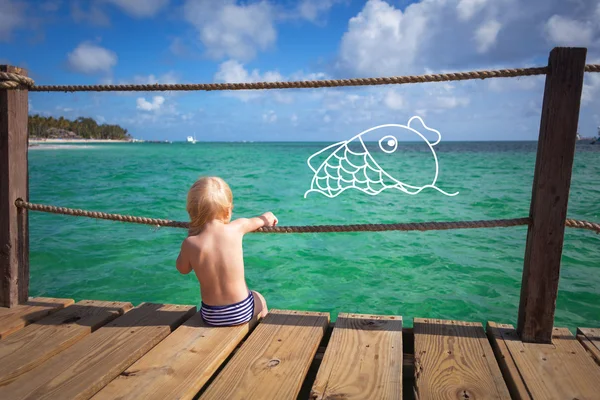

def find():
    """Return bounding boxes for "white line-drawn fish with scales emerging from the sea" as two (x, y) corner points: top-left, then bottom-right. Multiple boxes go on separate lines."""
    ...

(304, 116), (458, 198)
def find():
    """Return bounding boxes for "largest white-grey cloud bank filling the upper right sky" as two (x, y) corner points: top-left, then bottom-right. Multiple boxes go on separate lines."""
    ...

(335, 0), (600, 77)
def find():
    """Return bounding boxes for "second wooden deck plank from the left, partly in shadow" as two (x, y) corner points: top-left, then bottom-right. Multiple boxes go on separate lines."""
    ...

(0, 300), (132, 386)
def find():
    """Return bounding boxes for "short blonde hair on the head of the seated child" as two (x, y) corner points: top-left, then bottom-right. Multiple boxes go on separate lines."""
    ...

(186, 176), (233, 235)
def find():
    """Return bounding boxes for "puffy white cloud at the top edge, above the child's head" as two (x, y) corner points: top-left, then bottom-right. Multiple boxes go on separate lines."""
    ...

(184, 0), (277, 60)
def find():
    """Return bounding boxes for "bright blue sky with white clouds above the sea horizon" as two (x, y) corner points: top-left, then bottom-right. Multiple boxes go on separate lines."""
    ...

(0, 0), (600, 141)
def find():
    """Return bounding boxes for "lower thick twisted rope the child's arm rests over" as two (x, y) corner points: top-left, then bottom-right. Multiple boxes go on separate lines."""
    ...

(15, 199), (600, 233)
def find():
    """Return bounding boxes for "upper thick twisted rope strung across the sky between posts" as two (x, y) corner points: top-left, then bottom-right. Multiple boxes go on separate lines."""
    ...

(0, 64), (600, 92)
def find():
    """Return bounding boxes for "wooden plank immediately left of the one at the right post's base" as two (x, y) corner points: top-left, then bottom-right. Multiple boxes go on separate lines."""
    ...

(414, 318), (510, 400)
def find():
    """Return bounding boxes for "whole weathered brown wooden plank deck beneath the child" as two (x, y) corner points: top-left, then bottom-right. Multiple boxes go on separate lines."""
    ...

(0, 298), (600, 400)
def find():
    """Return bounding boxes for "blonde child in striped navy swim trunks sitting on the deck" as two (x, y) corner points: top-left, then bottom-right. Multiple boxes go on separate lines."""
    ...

(177, 177), (277, 326)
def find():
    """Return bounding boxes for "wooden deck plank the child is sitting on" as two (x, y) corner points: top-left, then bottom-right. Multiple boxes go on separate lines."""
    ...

(93, 313), (256, 400)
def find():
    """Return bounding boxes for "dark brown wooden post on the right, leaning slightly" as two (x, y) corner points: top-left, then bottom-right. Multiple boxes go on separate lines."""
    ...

(517, 47), (587, 343)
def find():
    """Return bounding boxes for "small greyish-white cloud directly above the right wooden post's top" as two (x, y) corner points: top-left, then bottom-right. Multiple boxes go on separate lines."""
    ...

(545, 15), (594, 46)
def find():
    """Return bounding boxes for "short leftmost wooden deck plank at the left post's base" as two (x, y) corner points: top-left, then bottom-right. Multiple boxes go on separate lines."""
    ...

(0, 297), (74, 339)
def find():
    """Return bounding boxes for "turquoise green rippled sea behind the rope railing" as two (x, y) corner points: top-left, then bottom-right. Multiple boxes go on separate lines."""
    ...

(29, 142), (600, 330)
